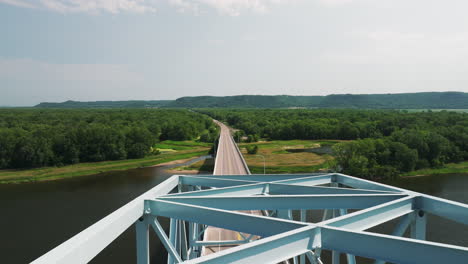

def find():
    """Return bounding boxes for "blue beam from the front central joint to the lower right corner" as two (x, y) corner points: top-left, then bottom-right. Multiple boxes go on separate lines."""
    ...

(321, 227), (468, 264)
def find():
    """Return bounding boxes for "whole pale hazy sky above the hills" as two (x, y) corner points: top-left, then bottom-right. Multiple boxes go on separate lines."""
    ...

(0, 0), (468, 106)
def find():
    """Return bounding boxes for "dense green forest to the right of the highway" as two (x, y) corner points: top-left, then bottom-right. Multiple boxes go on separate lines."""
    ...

(200, 109), (468, 178)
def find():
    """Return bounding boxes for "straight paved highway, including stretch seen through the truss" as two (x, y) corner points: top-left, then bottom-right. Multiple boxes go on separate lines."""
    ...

(202, 120), (261, 256)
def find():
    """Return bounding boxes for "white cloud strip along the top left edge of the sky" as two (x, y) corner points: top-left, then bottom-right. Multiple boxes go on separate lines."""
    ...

(0, 0), (156, 14)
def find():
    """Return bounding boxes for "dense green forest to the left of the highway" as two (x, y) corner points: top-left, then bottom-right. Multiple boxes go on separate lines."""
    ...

(0, 109), (216, 169)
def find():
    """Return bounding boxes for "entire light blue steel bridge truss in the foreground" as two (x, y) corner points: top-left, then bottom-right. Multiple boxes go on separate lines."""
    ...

(33, 173), (468, 264)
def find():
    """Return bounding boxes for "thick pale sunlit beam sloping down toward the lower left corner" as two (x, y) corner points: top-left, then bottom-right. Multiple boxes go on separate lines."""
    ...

(29, 176), (179, 264)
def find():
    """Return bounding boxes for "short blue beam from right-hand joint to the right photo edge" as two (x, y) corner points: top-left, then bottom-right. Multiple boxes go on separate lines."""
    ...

(416, 195), (468, 225)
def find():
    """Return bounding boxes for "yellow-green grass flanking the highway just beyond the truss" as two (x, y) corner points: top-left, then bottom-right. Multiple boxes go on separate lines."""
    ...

(176, 140), (339, 174)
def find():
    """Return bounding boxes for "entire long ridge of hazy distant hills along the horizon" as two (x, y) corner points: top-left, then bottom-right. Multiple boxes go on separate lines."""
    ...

(36, 92), (468, 109)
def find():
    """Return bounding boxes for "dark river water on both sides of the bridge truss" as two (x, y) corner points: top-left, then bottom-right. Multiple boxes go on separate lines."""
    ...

(0, 165), (468, 264)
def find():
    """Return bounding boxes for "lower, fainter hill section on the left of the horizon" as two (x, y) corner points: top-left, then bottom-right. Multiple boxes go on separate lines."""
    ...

(35, 100), (171, 108)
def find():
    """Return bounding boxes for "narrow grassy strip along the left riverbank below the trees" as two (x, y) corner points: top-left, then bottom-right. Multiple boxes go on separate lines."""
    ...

(0, 141), (211, 184)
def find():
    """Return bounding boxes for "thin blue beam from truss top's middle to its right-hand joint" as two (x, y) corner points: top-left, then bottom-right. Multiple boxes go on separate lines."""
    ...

(268, 183), (394, 195)
